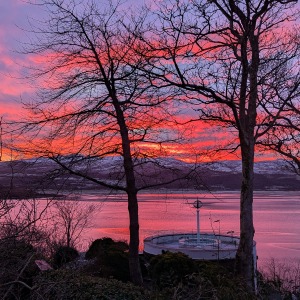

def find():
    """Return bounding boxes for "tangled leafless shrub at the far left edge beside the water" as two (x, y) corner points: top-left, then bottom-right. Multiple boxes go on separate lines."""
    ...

(0, 199), (49, 299)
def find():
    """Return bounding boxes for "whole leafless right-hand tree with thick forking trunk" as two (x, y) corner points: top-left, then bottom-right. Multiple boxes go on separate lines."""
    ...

(139, 0), (299, 289)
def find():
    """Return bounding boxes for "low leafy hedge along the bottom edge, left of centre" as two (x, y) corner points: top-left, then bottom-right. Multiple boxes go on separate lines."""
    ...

(31, 269), (151, 300)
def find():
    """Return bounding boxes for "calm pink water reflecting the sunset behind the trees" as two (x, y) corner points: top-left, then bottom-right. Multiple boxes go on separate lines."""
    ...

(73, 192), (300, 264)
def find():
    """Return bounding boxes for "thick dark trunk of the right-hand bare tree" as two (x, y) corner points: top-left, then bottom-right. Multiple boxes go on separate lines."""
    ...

(237, 31), (259, 291)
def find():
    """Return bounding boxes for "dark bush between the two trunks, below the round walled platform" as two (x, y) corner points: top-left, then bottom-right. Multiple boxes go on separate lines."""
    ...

(150, 252), (256, 300)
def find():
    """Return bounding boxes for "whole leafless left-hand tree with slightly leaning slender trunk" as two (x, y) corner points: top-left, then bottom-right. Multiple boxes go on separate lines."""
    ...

(19, 0), (191, 284)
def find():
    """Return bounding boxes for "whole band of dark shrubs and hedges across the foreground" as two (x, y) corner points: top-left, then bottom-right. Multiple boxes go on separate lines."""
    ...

(0, 238), (300, 300)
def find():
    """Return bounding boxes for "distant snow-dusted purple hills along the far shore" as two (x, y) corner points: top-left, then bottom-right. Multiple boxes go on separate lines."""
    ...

(0, 156), (300, 198)
